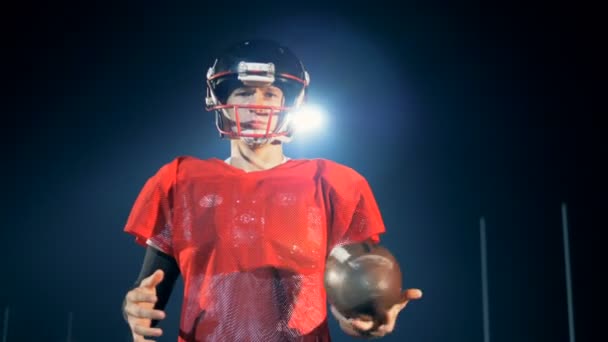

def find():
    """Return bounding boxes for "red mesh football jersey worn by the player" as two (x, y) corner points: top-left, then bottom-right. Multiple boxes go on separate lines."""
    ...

(125, 157), (384, 342)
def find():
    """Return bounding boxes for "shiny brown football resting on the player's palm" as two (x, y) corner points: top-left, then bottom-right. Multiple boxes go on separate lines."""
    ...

(324, 242), (402, 319)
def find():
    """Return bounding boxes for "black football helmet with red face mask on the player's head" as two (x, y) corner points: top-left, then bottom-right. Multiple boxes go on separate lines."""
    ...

(206, 41), (310, 145)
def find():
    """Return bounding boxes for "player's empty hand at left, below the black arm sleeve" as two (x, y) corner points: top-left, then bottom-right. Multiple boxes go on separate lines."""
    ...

(124, 270), (165, 342)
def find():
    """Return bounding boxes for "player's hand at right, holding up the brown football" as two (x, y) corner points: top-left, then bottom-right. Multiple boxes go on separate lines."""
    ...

(331, 289), (422, 338)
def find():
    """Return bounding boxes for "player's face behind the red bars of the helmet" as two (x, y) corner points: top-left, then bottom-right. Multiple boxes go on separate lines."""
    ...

(226, 86), (283, 134)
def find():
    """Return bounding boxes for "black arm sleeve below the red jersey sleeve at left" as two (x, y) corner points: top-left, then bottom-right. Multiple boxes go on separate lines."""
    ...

(123, 246), (180, 326)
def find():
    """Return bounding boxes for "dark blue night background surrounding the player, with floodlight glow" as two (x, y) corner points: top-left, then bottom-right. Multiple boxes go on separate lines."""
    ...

(0, 1), (601, 342)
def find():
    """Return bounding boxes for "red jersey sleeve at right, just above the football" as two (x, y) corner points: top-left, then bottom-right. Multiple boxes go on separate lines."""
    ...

(329, 177), (385, 249)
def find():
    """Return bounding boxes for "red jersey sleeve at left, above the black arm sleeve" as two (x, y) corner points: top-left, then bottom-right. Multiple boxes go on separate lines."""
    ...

(124, 159), (178, 255)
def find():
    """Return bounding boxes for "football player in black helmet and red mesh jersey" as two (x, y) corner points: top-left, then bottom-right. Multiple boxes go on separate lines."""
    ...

(123, 41), (421, 342)
